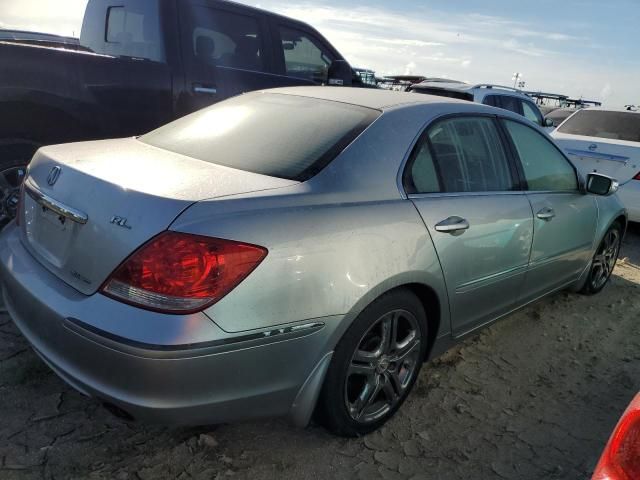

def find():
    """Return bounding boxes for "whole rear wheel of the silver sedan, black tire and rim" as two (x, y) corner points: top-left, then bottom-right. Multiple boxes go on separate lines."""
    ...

(316, 289), (428, 437)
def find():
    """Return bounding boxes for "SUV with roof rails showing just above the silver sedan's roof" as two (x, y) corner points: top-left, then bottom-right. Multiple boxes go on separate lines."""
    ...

(407, 79), (550, 127)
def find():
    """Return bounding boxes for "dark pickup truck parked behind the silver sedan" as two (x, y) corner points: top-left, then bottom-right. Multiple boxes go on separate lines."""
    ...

(0, 0), (354, 225)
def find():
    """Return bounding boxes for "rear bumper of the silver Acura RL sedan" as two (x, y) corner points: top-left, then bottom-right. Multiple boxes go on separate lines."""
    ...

(0, 227), (341, 425)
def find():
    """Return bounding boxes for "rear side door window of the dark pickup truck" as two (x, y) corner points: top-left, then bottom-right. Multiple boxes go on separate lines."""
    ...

(187, 7), (264, 71)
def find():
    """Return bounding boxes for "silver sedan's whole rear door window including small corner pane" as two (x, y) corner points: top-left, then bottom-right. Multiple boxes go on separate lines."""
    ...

(405, 117), (517, 193)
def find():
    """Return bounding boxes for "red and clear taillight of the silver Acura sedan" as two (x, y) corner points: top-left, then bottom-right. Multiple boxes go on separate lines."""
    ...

(102, 231), (267, 313)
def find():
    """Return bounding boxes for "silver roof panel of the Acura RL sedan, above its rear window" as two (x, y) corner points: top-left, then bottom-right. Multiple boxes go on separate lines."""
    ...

(263, 87), (468, 110)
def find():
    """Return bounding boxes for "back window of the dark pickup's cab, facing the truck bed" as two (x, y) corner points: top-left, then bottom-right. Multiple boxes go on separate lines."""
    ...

(104, 1), (164, 62)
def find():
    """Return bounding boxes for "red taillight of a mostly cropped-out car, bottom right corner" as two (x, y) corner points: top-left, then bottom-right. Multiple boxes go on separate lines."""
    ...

(592, 395), (640, 480)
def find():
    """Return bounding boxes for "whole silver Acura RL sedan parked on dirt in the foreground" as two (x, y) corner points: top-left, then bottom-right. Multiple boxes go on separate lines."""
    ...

(0, 87), (627, 436)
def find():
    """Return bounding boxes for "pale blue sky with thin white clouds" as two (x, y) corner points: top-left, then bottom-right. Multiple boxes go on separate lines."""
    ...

(0, 0), (640, 106)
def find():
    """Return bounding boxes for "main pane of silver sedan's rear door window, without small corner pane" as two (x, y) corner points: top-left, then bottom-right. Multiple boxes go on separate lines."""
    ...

(428, 117), (515, 192)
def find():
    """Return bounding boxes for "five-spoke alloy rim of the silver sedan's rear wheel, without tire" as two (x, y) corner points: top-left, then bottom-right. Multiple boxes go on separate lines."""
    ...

(345, 310), (422, 423)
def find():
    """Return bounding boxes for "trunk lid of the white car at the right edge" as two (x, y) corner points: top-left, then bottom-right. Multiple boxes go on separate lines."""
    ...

(552, 132), (640, 184)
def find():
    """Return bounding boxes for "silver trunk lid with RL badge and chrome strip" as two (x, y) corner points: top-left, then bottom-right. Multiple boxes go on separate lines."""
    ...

(20, 139), (297, 295)
